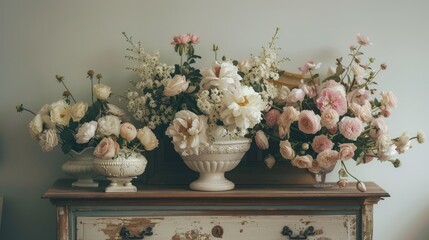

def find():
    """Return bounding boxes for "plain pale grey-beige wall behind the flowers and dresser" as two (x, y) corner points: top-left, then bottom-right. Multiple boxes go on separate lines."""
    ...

(0, 0), (429, 240)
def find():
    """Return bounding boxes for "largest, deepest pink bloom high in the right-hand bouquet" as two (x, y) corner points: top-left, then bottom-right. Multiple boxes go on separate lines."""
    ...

(316, 88), (347, 116)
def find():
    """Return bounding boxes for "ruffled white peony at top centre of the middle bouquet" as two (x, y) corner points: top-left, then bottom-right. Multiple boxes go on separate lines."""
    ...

(200, 62), (243, 91)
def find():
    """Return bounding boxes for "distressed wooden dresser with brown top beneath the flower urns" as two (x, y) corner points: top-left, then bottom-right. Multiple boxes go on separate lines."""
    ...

(43, 180), (389, 240)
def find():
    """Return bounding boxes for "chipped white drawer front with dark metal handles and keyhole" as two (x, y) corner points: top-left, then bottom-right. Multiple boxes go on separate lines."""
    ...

(76, 215), (356, 240)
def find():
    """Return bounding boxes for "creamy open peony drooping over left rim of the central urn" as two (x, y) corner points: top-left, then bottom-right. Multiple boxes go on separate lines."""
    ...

(165, 110), (208, 156)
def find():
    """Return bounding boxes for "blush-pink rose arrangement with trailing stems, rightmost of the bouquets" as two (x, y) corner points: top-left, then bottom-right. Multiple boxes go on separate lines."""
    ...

(255, 35), (424, 191)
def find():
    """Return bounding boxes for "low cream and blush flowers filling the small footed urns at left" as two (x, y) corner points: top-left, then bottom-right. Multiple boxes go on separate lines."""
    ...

(16, 70), (158, 159)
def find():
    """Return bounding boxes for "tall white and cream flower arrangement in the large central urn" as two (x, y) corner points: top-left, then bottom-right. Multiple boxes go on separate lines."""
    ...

(123, 33), (279, 156)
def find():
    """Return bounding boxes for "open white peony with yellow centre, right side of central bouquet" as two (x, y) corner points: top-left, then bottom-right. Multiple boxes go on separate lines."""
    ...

(220, 86), (266, 130)
